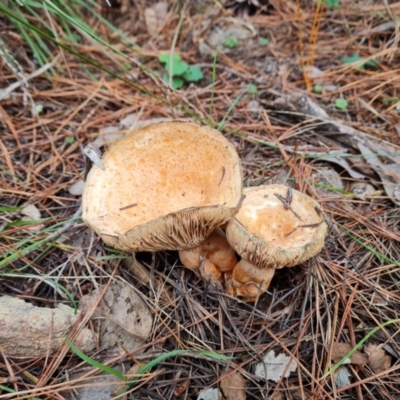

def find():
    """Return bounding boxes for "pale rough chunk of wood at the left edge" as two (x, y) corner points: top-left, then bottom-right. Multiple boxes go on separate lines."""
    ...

(0, 296), (96, 358)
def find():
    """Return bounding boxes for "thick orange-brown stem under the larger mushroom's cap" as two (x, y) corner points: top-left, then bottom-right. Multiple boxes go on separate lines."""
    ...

(179, 228), (237, 282)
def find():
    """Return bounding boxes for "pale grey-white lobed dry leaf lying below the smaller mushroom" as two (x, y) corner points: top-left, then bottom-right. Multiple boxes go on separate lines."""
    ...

(255, 350), (297, 382)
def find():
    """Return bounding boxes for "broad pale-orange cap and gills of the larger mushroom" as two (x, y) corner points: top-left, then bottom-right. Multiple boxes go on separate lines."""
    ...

(82, 122), (242, 260)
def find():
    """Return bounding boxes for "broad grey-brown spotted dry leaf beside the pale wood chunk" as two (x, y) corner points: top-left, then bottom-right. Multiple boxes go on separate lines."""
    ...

(80, 282), (153, 355)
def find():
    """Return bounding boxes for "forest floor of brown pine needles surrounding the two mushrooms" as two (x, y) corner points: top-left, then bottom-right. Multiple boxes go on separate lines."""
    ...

(0, 0), (400, 400)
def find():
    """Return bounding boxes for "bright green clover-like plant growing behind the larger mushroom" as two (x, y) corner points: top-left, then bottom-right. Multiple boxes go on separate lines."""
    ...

(158, 53), (203, 89)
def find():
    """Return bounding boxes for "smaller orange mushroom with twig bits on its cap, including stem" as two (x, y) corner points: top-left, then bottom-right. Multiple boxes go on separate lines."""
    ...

(226, 184), (328, 301)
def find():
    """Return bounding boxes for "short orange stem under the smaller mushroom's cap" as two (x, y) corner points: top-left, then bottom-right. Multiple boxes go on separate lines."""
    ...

(227, 258), (275, 301)
